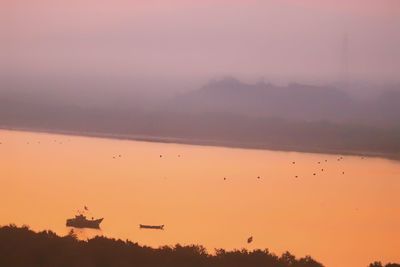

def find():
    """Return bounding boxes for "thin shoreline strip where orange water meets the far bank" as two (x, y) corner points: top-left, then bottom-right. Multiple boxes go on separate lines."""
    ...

(0, 125), (400, 161)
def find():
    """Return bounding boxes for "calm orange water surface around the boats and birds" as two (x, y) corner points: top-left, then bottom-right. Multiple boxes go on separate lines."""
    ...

(0, 131), (400, 267)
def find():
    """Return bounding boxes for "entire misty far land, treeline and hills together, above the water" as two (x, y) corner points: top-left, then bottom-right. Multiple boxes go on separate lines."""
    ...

(0, 79), (400, 158)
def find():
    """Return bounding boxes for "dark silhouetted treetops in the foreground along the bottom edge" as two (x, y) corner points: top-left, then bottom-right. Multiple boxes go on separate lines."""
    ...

(0, 225), (400, 267)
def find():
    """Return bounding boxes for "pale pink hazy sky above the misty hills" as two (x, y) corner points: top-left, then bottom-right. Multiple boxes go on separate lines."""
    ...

(0, 0), (400, 84)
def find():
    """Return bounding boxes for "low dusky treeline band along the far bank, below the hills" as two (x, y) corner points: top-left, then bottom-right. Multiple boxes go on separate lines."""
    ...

(0, 105), (400, 158)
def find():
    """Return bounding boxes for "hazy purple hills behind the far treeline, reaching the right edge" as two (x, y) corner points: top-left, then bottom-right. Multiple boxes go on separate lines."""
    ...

(166, 78), (400, 126)
